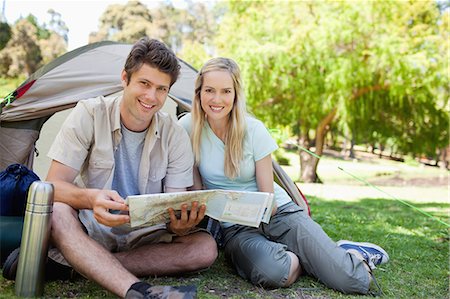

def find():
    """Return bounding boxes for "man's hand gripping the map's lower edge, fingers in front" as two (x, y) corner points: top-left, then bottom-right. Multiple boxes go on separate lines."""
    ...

(169, 201), (206, 236)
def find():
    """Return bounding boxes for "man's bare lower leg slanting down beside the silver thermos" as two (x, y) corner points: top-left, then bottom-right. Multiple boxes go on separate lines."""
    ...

(52, 202), (139, 298)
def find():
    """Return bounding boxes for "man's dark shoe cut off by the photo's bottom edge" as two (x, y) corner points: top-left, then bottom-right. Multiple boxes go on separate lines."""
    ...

(125, 281), (197, 299)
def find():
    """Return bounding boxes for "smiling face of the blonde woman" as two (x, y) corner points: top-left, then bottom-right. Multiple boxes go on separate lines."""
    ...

(200, 71), (236, 122)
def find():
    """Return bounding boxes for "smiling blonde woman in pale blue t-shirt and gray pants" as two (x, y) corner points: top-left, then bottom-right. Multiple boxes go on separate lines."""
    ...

(180, 58), (389, 294)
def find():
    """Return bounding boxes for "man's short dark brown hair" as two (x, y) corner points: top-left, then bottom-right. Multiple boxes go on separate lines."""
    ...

(124, 37), (180, 86)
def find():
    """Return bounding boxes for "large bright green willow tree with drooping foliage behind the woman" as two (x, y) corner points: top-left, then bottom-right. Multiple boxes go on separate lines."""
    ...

(217, 1), (448, 182)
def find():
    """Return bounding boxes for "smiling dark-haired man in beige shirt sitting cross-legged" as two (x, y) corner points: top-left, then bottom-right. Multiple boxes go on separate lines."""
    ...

(3, 37), (217, 298)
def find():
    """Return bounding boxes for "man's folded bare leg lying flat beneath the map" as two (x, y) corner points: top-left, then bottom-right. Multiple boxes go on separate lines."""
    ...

(114, 232), (217, 277)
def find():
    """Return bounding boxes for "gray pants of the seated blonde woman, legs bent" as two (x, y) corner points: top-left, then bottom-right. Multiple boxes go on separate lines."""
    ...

(224, 202), (369, 294)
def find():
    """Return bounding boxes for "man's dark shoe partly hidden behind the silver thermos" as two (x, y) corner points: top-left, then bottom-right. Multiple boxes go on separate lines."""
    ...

(2, 247), (81, 281)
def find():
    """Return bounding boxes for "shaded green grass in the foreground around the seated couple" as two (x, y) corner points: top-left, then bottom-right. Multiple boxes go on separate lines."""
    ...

(0, 197), (450, 298)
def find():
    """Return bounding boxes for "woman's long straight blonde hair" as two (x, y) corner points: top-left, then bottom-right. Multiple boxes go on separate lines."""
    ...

(191, 57), (247, 178)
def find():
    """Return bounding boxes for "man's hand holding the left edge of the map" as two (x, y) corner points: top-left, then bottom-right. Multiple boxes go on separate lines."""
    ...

(91, 190), (130, 226)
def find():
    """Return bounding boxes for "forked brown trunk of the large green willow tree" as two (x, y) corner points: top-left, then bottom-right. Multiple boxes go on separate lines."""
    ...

(299, 108), (337, 183)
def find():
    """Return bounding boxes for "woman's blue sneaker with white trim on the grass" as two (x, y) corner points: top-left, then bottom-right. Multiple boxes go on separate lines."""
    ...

(336, 240), (389, 269)
